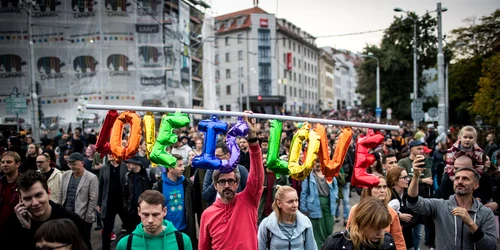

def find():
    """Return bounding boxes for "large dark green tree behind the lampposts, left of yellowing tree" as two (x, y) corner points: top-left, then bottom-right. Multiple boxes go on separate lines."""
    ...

(357, 13), (437, 119)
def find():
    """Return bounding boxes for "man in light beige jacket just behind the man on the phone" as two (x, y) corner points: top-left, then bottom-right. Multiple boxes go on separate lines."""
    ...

(36, 154), (62, 203)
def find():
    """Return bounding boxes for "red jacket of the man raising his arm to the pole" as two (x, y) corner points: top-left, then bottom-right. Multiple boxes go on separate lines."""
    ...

(198, 144), (264, 250)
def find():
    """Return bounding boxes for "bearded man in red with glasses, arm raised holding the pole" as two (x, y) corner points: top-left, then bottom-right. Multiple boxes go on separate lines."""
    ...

(198, 111), (264, 250)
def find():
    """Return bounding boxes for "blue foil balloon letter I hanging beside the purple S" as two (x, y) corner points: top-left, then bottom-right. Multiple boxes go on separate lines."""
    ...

(192, 115), (232, 169)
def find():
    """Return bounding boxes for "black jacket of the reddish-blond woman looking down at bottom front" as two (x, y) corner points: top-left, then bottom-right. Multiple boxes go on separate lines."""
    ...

(321, 230), (396, 250)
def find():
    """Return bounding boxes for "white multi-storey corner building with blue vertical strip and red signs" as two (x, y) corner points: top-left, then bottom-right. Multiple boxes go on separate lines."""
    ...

(215, 7), (319, 114)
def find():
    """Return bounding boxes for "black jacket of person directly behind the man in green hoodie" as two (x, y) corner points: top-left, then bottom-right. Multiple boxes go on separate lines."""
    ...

(123, 167), (154, 215)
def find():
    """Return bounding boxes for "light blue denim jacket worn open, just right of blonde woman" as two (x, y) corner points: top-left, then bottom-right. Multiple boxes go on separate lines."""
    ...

(299, 172), (339, 219)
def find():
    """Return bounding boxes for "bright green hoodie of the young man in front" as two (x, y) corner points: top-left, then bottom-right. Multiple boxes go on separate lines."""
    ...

(116, 220), (193, 250)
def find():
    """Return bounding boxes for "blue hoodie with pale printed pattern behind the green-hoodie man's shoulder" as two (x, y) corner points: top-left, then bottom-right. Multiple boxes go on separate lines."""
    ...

(162, 172), (187, 231)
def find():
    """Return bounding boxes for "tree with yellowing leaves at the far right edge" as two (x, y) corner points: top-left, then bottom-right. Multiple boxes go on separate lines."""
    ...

(447, 9), (500, 124)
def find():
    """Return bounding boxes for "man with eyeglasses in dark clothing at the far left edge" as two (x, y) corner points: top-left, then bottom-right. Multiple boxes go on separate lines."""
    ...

(0, 151), (21, 231)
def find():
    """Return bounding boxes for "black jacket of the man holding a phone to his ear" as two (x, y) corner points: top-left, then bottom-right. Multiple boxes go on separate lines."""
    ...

(0, 201), (92, 250)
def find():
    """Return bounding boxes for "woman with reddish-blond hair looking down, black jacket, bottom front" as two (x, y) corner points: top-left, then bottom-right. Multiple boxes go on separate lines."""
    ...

(321, 196), (396, 250)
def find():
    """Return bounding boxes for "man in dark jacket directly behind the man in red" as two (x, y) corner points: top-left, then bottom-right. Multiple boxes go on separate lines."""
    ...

(201, 143), (248, 206)
